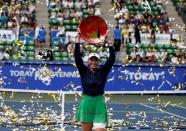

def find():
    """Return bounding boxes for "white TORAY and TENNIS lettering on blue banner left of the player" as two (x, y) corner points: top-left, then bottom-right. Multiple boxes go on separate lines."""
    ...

(10, 70), (79, 80)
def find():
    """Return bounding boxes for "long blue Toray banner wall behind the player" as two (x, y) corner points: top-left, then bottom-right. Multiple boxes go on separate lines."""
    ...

(1, 62), (186, 92)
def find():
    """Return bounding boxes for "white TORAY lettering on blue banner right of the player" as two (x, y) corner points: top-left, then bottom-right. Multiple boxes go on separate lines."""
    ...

(121, 70), (164, 81)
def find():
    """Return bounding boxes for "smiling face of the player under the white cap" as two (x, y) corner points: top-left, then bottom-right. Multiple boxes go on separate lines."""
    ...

(88, 56), (100, 71)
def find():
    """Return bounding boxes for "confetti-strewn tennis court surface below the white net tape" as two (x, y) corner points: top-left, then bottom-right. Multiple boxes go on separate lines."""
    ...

(0, 93), (186, 131)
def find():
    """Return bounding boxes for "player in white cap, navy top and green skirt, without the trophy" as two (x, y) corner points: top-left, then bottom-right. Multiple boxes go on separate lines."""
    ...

(74, 33), (115, 131)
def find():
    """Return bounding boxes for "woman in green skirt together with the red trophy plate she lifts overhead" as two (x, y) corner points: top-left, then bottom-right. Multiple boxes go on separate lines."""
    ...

(74, 16), (115, 131)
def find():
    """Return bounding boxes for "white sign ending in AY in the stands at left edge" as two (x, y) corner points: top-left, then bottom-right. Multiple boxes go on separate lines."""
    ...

(0, 30), (16, 41)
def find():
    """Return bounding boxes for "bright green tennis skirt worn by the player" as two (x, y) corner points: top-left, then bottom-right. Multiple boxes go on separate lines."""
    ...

(76, 95), (108, 123)
